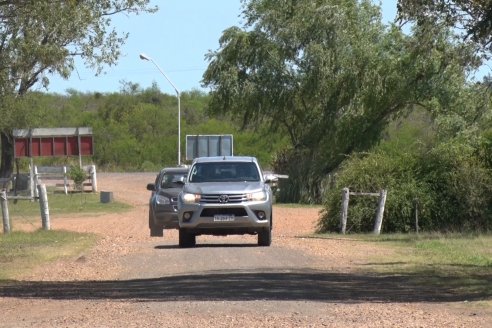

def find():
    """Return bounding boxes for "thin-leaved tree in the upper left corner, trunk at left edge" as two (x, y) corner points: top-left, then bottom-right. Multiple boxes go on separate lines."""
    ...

(0, 0), (157, 177)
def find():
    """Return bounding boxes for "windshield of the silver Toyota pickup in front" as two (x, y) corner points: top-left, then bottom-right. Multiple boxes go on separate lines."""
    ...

(190, 162), (260, 182)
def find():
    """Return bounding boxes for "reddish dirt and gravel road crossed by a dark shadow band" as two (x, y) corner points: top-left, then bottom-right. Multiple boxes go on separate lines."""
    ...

(0, 174), (492, 327)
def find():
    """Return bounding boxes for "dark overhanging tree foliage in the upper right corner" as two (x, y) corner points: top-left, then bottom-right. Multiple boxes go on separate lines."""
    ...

(398, 0), (492, 52)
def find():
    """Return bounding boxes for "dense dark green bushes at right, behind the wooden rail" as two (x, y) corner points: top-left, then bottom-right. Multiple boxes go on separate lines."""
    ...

(318, 142), (492, 232)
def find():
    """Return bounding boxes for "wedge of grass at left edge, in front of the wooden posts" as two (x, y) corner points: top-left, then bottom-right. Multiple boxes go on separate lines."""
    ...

(0, 230), (97, 281)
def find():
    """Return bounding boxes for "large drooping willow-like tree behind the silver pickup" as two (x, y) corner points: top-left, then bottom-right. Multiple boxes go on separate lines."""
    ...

(203, 0), (475, 202)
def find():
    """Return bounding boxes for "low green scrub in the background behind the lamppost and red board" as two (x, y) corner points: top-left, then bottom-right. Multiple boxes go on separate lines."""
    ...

(11, 88), (286, 172)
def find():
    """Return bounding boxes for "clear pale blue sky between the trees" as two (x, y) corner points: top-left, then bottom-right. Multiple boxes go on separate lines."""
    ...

(42, 0), (397, 94)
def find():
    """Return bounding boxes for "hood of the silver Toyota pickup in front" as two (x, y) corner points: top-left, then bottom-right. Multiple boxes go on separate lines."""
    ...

(183, 181), (265, 194)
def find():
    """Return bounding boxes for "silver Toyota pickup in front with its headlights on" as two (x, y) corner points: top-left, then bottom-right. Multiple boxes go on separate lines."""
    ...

(178, 156), (272, 247)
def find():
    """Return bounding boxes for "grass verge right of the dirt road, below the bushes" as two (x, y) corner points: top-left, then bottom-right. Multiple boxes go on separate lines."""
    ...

(319, 233), (492, 307)
